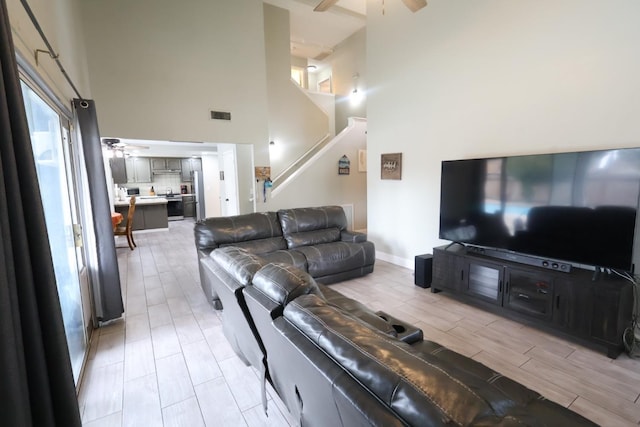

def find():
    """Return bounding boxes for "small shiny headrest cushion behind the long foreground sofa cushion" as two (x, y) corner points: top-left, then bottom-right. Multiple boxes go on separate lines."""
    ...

(253, 263), (322, 306)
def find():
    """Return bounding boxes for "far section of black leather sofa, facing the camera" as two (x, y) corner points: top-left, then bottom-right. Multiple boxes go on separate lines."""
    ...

(194, 206), (375, 309)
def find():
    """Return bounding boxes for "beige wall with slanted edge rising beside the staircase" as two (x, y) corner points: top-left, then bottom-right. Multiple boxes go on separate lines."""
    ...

(264, 4), (329, 177)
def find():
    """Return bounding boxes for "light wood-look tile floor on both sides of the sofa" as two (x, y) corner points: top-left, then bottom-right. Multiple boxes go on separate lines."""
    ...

(78, 220), (640, 427)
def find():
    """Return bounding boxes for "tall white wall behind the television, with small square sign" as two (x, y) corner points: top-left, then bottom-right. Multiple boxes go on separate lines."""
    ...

(367, 0), (640, 266)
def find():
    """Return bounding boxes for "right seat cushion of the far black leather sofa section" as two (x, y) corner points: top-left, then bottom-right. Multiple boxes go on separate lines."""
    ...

(295, 242), (376, 277)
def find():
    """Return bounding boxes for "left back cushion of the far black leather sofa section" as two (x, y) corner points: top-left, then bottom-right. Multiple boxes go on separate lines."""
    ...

(194, 212), (287, 254)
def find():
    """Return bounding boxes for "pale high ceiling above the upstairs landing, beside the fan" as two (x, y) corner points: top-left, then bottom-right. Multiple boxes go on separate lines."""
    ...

(264, 0), (367, 60)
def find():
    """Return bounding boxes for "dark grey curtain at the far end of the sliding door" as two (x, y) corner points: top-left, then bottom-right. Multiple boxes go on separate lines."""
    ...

(73, 99), (124, 322)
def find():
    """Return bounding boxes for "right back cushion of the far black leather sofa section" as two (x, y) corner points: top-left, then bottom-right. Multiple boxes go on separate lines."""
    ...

(278, 206), (347, 249)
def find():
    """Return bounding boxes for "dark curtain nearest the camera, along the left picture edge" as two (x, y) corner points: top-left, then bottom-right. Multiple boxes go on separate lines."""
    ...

(0, 0), (81, 427)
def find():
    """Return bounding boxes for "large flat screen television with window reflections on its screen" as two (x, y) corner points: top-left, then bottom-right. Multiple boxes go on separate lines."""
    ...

(439, 148), (640, 271)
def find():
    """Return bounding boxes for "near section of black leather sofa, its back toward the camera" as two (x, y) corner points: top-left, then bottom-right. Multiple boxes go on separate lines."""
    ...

(202, 247), (594, 426)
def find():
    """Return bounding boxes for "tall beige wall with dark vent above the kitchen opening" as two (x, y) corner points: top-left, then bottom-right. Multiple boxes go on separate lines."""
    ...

(82, 0), (268, 167)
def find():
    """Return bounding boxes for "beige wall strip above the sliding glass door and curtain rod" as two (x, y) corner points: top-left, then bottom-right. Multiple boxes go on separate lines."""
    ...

(7, 0), (91, 109)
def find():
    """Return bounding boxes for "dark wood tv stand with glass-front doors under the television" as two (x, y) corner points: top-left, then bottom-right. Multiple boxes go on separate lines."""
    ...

(431, 245), (633, 359)
